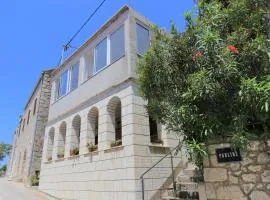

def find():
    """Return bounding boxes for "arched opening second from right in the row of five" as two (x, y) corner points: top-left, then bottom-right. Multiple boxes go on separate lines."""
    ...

(87, 107), (99, 146)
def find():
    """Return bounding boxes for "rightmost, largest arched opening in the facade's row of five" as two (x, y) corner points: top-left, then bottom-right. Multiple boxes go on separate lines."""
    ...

(107, 97), (122, 146)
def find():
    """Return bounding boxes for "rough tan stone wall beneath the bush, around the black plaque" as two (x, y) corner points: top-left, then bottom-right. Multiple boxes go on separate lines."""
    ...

(204, 140), (270, 200)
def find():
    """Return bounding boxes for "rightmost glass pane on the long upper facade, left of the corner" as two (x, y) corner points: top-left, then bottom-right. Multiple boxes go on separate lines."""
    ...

(111, 26), (125, 63)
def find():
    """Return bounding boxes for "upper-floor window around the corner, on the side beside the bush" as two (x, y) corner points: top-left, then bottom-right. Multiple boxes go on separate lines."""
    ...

(136, 23), (150, 55)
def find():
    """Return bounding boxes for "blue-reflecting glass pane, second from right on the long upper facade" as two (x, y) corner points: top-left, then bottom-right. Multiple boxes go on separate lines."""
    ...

(95, 38), (107, 72)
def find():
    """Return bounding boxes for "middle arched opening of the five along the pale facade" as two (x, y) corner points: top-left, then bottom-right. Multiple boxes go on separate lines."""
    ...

(70, 115), (81, 156)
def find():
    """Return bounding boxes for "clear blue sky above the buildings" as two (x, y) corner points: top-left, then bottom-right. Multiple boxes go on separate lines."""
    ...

(0, 0), (193, 164)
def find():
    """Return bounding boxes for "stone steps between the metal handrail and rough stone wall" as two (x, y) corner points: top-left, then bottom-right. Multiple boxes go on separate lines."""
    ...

(161, 164), (199, 200)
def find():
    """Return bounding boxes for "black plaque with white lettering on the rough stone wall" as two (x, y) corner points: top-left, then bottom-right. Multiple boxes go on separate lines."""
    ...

(216, 147), (242, 163)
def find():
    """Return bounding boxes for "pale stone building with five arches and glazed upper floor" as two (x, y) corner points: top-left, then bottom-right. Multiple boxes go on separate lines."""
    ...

(39, 6), (190, 200)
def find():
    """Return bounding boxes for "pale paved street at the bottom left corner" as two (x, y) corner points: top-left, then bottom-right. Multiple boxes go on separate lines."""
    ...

(0, 178), (50, 200)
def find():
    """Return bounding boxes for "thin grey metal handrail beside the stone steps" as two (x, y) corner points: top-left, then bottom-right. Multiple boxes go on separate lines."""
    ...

(140, 144), (182, 200)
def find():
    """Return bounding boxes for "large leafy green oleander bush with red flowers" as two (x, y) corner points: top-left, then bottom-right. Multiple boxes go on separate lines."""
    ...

(138, 0), (270, 175)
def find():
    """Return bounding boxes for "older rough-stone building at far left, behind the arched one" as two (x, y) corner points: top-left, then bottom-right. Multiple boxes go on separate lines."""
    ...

(7, 70), (53, 184)
